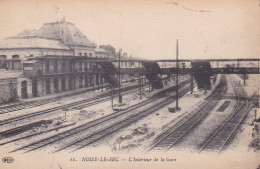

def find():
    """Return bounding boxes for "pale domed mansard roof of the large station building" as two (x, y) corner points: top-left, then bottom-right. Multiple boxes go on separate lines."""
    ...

(0, 20), (96, 50)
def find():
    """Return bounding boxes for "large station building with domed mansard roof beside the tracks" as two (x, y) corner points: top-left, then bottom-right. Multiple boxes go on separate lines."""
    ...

(0, 21), (126, 101)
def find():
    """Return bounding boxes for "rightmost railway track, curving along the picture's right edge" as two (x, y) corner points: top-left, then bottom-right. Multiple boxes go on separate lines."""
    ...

(198, 76), (251, 153)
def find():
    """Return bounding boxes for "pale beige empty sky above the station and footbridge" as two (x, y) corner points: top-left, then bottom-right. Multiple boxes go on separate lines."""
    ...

(0, 0), (260, 59)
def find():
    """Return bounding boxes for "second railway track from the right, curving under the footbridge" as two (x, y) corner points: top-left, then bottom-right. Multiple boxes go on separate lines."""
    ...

(147, 76), (227, 152)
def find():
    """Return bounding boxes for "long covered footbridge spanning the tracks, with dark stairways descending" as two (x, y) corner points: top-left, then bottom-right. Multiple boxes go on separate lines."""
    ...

(23, 56), (260, 91)
